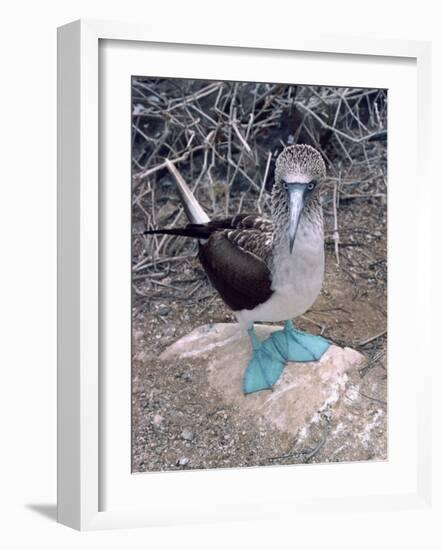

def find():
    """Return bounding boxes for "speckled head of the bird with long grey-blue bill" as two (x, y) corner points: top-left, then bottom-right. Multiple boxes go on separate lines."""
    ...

(272, 145), (325, 253)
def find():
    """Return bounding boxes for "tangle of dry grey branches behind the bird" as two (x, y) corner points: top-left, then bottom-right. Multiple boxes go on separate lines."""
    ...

(132, 77), (387, 272)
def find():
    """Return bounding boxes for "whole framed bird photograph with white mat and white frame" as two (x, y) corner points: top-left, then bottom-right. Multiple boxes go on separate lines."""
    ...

(58, 21), (431, 529)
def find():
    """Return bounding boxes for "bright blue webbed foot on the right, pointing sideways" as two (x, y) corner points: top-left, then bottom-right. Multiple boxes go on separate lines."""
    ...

(270, 321), (331, 363)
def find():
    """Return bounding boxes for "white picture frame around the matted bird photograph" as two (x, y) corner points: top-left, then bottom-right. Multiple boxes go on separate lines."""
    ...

(58, 21), (432, 530)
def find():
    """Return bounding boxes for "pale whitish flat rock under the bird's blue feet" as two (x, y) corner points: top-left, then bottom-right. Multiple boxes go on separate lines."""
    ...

(160, 323), (370, 439)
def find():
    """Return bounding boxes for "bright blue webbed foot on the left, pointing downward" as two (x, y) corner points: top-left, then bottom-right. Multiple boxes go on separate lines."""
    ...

(243, 325), (286, 394)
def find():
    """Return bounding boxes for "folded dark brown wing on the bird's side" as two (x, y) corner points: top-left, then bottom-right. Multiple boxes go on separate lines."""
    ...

(198, 229), (273, 311)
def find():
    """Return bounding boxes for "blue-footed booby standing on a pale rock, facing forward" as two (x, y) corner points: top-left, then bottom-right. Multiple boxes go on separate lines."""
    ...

(146, 145), (330, 394)
